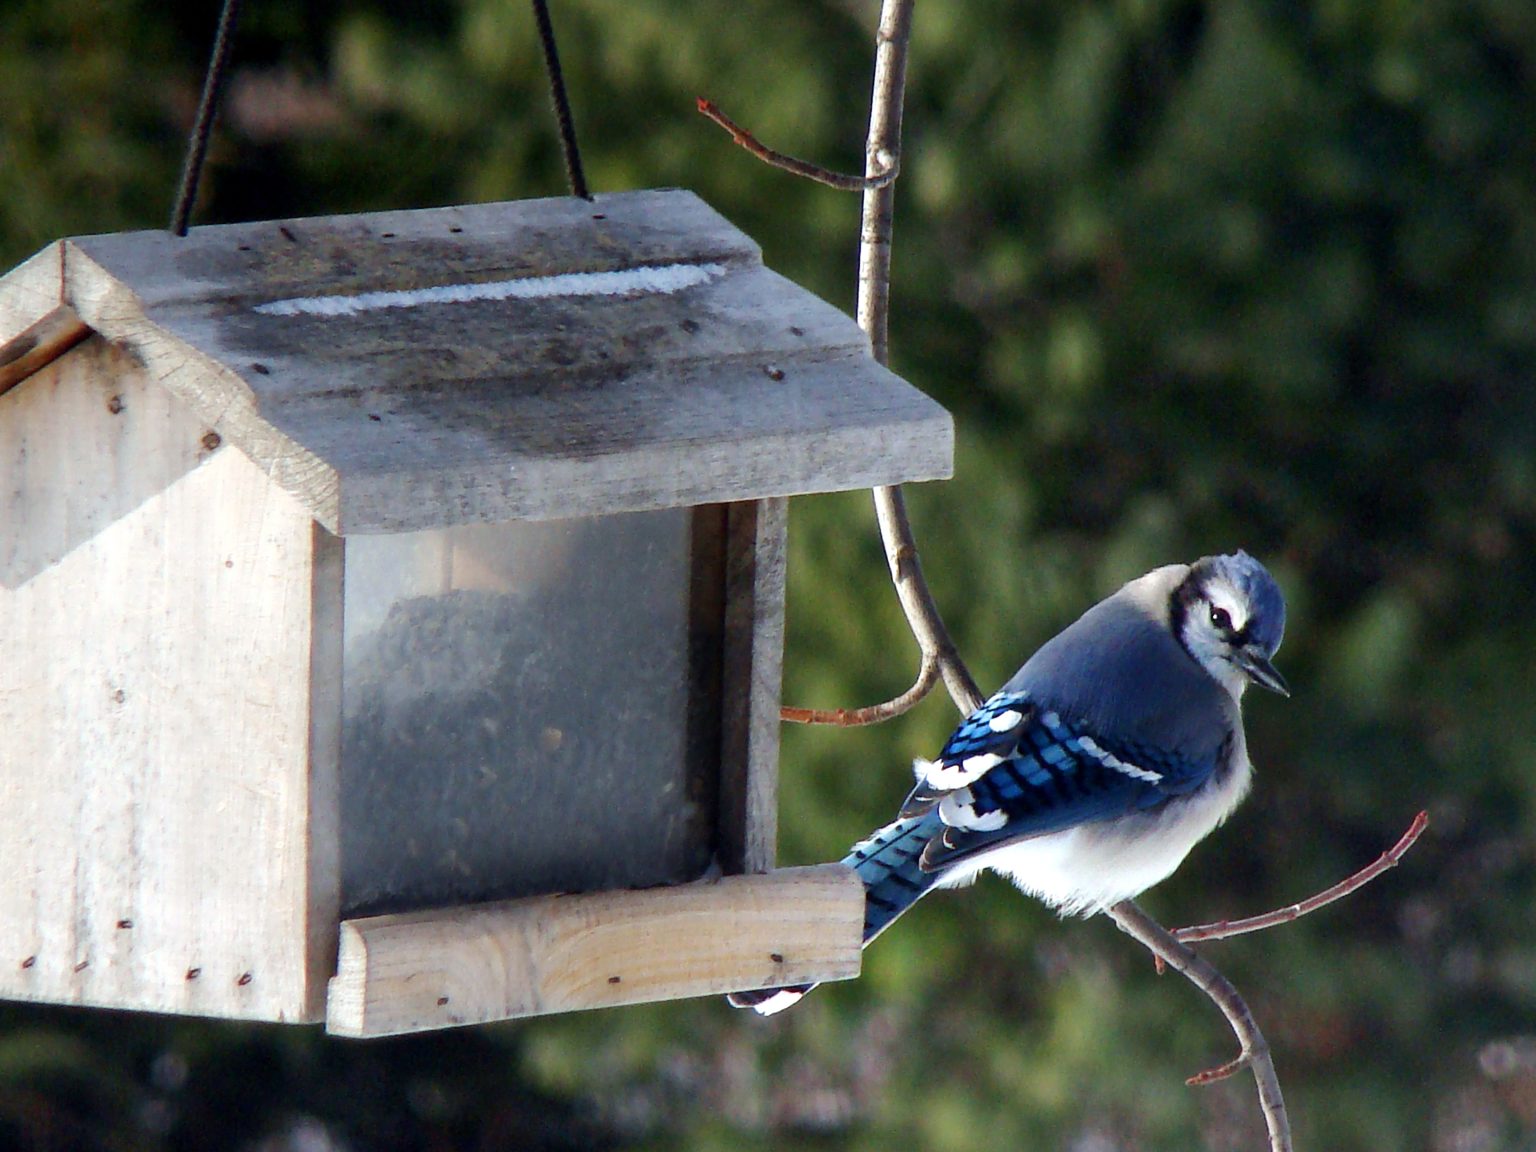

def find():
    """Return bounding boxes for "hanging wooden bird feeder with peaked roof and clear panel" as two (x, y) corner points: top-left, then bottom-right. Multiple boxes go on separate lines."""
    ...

(0, 192), (952, 1035)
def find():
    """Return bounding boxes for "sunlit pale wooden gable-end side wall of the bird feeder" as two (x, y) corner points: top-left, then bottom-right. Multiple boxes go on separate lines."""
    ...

(0, 338), (339, 1020)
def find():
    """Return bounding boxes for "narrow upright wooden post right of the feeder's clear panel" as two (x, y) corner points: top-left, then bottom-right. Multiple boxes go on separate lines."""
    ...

(720, 498), (788, 872)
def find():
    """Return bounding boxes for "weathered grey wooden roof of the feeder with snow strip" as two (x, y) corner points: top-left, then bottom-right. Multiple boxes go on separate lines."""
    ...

(0, 190), (952, 533)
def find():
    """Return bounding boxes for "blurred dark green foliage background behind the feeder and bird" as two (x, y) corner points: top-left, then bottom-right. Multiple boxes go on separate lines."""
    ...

(0, 0), (1536, 1152)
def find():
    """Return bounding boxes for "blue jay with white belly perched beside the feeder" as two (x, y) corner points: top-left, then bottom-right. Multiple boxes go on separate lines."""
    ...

(731, 551), (1290, 1015)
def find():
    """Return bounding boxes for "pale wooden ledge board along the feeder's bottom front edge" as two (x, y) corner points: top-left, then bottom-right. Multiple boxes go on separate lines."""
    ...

(326, 865), (863, 1037)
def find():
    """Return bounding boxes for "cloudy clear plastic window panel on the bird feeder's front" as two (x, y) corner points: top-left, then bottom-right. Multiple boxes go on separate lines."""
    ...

(341, 508), (719, 915)
